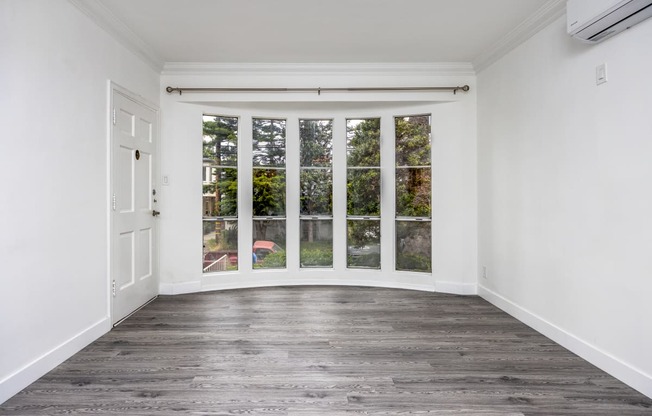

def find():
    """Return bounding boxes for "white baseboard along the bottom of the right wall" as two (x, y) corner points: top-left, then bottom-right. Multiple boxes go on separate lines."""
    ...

(478, 286), (652, 398)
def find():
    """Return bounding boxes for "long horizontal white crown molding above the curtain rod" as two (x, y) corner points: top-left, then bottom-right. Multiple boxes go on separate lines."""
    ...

(162, 62), (475, 76)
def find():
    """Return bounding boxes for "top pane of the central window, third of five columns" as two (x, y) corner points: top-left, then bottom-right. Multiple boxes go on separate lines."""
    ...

(299, 120), (333, 167)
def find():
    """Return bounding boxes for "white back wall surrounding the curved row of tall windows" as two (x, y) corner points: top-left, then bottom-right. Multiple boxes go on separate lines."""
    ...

(159, 71), (477, 293)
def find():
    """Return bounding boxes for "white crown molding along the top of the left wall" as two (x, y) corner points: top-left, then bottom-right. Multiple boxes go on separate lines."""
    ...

(68, 0), (163, 72)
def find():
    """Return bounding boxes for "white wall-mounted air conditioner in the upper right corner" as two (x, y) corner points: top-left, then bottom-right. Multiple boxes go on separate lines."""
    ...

(566, 0), (652, 43)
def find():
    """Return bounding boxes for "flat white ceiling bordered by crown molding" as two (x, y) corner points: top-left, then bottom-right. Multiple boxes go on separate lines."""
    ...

(95, 0), (560, 64)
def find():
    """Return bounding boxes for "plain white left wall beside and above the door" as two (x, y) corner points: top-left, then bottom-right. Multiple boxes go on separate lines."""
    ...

(0, 0), (159, 402)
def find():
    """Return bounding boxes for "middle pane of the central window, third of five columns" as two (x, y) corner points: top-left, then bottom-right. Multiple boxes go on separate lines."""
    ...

(300, 169), (333, 215)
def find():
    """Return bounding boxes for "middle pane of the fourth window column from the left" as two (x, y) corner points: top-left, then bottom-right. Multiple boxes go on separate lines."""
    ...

(346, 168), (380, 216)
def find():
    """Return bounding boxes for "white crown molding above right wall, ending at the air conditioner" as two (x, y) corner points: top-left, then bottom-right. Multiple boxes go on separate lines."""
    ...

(473, 0), (566, 73)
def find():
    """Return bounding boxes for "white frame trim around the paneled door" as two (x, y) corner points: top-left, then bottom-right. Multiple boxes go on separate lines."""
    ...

(106, 80), (161, 327)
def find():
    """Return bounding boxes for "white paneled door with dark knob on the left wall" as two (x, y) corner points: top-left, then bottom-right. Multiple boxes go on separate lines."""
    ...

(111, 88), (158, 324)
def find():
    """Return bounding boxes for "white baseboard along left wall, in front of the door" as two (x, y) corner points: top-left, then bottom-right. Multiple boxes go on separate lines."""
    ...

(0, 317), (111, 404)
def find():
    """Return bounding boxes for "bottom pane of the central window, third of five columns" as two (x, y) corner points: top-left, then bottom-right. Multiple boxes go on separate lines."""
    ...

(300, 220), (333, 267)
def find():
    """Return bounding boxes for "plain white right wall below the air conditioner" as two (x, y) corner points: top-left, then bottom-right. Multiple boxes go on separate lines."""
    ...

(478, 13), (652, 396)
